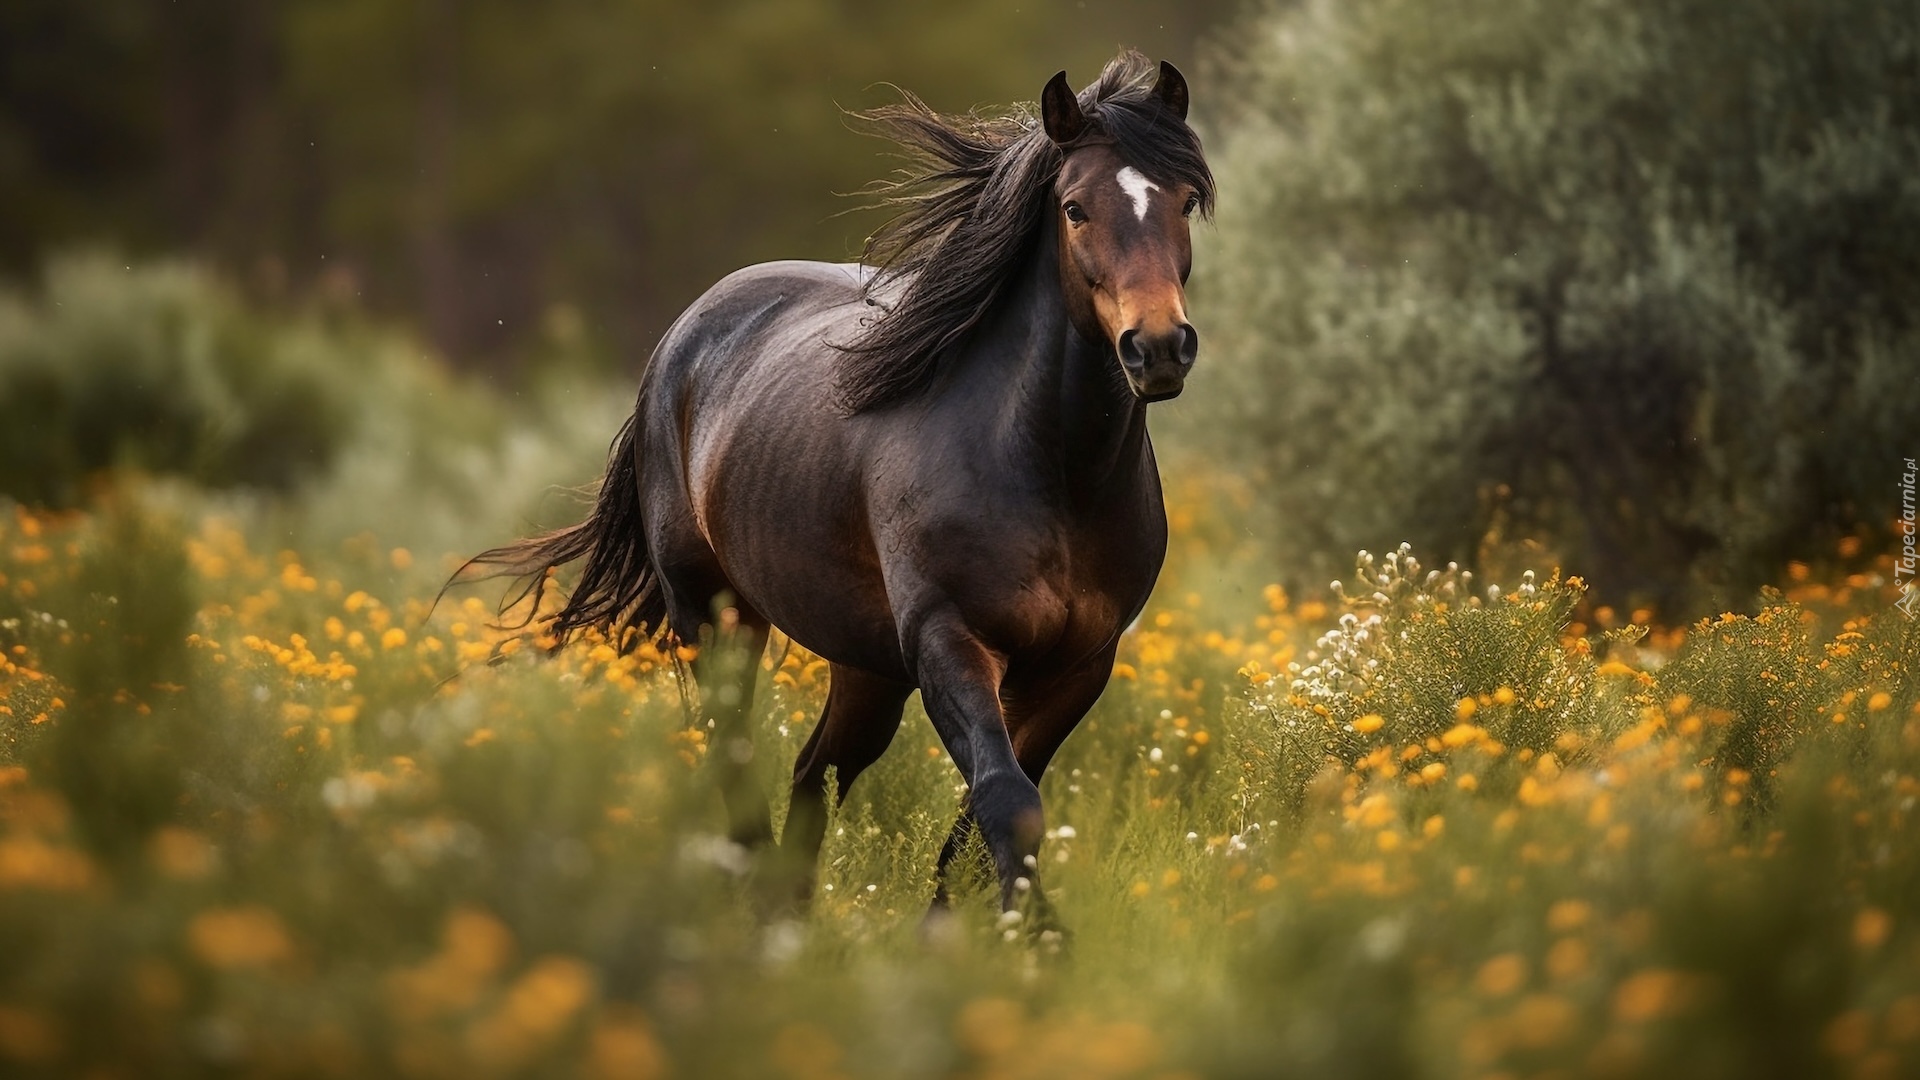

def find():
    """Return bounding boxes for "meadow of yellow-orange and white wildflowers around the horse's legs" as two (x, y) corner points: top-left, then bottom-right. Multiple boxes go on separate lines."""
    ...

(0, 480), (1920, 1080)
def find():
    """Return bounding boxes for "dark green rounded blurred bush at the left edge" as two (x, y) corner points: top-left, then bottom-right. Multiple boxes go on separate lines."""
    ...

(0, 256), (359, 505)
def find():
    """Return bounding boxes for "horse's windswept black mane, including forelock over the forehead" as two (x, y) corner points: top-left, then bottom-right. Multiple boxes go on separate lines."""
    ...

(837, 50), (1213, 413)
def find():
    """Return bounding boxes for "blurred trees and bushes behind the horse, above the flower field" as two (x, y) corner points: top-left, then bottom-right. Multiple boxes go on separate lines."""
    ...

(0, 0), (1920, 615)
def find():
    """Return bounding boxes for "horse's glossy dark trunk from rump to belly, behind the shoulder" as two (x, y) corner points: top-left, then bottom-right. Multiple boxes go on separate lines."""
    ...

(625, 261), (904, 676)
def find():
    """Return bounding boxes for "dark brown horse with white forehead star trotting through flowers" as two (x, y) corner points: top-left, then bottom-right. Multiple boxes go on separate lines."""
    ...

(472, 52), (1213, 911)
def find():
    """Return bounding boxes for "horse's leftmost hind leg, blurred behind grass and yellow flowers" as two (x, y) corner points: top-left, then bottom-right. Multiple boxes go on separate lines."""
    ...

(693, 607), (774, 847)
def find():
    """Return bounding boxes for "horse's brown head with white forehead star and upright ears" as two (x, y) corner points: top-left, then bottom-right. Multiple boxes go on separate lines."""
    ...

(1041, 61), (1210, 402)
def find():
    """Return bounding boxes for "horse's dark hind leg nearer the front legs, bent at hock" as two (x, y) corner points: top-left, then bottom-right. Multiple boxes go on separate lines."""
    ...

(780, 665), (914, 899)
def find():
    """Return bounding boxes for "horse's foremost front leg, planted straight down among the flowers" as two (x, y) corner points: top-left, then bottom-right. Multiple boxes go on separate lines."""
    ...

(914, 615), (1046, 911)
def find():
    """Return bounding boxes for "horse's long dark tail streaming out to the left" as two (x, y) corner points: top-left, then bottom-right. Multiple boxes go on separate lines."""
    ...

(447, 413), (666, 651)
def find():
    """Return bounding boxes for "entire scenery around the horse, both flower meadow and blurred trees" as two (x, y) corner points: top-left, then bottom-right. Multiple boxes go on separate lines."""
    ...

(0, 0), (1920, 1080)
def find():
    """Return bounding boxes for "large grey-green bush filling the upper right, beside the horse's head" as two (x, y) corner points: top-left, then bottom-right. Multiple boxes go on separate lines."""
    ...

(1194, 0), (1920, 611)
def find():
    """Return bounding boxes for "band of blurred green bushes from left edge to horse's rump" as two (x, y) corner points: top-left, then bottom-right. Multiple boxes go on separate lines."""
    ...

(0, 254), (630, 564)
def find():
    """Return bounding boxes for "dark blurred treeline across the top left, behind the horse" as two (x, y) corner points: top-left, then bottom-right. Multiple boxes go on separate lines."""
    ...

(0, 0), (1233, 365)
